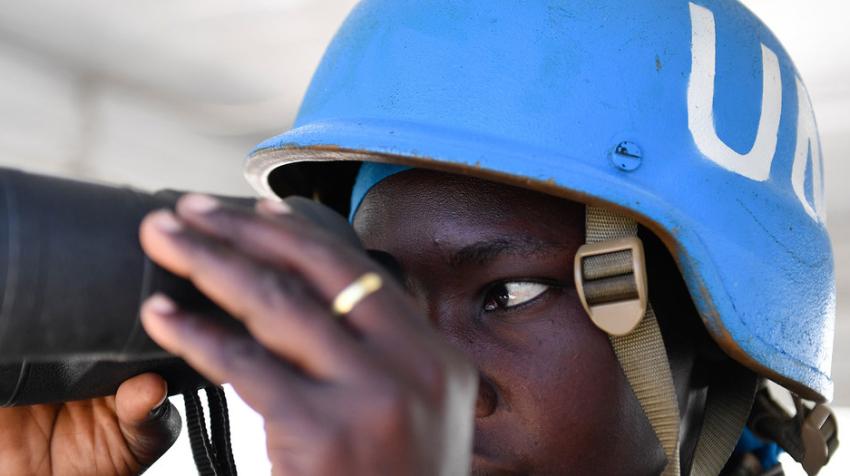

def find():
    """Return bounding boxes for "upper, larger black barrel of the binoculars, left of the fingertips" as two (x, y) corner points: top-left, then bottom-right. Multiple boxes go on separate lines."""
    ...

(0, 170), (200, 362)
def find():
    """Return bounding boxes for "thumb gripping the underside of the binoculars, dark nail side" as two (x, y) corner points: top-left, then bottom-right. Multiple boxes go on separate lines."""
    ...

(115, 373), (181, 468)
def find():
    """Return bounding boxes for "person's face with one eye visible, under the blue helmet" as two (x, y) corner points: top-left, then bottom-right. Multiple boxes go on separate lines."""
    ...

(354, 170), (664, 475)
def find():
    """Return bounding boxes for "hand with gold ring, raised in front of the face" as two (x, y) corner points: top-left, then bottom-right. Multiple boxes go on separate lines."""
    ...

(140, 195), (478, 475)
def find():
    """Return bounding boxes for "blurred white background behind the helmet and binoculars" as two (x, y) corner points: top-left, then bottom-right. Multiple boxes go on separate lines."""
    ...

(0, 0), (850, 475)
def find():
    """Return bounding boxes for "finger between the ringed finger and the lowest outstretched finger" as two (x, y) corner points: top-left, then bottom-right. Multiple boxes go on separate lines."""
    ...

(141, 211), (358, 378)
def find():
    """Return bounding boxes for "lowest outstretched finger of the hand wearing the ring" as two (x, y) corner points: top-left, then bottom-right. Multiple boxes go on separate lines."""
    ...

(141, 294), (307, 414)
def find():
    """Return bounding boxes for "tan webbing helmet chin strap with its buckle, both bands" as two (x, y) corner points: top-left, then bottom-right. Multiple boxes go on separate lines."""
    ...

(575, 206), (757, 476)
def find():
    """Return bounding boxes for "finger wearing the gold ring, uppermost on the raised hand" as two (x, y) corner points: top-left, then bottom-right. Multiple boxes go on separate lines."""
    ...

(177, 194), (425, 338)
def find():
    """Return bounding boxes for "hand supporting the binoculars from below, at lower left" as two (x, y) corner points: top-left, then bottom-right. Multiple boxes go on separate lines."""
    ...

(0, 374), (180, 476)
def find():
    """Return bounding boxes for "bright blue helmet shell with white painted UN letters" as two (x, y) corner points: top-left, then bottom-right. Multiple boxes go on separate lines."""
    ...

(246, 0), (835, 400)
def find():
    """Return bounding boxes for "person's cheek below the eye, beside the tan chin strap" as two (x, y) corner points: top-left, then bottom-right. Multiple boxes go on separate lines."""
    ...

(470, 308), (663, 474)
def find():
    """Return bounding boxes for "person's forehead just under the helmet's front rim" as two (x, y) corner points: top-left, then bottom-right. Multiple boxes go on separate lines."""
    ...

(354, 169), (584, 243)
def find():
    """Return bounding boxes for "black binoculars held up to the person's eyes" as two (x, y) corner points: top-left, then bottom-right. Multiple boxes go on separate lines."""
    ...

(0, 168), (360, 406)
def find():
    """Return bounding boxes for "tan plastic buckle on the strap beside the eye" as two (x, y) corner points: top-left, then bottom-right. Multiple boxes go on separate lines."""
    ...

(574, 237), (648, 336)
